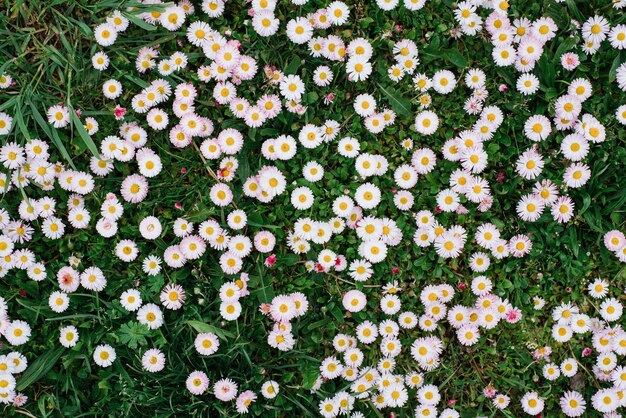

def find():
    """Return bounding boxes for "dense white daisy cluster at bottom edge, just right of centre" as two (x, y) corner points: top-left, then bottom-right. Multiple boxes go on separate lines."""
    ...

(315, 276), (522, 418)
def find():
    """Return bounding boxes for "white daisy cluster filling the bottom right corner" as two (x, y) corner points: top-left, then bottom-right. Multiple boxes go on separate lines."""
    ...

(522, 278), (626, 417)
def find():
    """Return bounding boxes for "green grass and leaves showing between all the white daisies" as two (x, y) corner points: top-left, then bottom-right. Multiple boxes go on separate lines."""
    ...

(0, 0), (626, 417)
